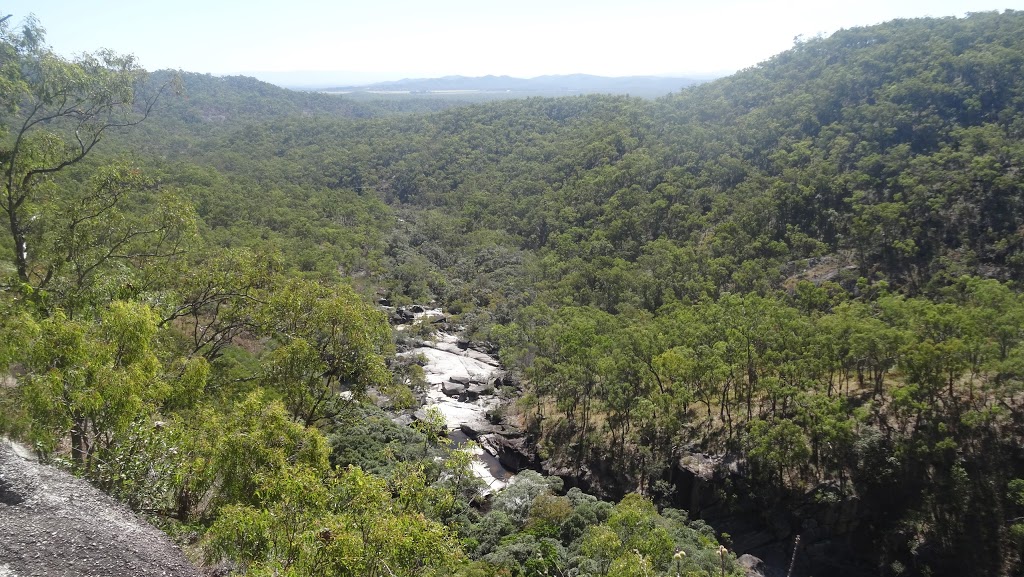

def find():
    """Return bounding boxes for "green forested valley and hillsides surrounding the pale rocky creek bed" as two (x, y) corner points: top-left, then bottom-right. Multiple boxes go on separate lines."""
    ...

(0, 11), (1024, 576)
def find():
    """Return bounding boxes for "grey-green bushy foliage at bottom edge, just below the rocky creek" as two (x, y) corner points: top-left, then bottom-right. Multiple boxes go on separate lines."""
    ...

(471, 489), (742, 577)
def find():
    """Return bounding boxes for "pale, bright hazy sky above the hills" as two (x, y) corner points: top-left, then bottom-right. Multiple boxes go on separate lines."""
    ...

(0, 0), (1024, 84)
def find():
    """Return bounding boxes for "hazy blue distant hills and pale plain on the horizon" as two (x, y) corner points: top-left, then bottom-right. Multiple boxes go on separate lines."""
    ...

(323, 74), (706, 96)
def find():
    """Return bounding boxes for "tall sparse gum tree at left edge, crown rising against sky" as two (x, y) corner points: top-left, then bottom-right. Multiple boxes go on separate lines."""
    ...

(0, 16), (183, 301)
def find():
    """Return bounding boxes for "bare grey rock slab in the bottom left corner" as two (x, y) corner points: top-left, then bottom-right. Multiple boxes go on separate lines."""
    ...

(0, 440), (199, 577)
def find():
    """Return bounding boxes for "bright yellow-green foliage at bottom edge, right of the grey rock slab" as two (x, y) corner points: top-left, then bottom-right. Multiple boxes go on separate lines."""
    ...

(206, 465), (460, 577)
